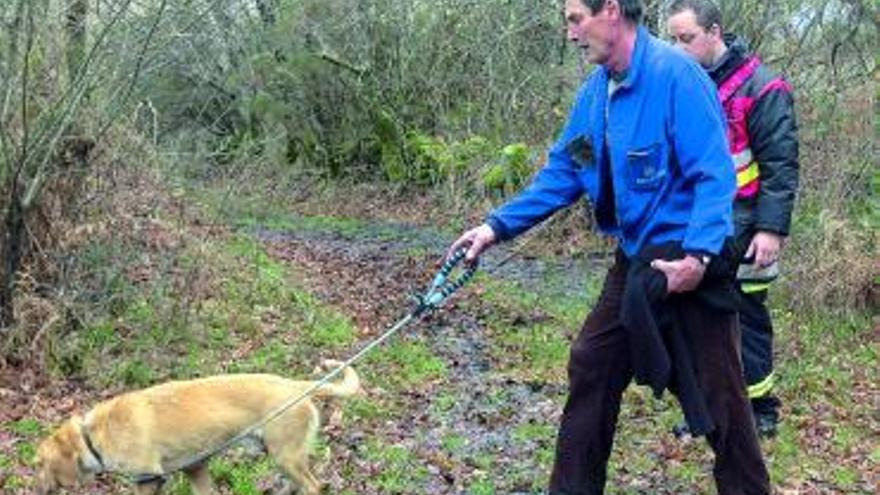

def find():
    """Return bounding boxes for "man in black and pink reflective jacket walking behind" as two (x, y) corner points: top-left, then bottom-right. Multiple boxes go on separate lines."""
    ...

(667, 0), (798, 436)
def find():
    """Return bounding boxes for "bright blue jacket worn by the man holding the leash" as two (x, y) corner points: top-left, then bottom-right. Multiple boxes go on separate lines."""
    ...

(487, 26), (736, 256)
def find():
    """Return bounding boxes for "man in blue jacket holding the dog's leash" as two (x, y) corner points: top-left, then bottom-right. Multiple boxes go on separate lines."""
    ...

(450, 0), (770, 495)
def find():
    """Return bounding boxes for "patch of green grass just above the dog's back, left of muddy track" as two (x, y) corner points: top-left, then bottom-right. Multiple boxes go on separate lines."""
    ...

(51, 235), (355, 388)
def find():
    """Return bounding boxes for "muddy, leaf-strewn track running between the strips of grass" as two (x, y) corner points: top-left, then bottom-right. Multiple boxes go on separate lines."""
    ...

(256, 224), (608, 494)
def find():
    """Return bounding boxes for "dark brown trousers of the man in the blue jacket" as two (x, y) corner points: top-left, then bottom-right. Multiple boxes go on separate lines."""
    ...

(550, 259), (770, 495)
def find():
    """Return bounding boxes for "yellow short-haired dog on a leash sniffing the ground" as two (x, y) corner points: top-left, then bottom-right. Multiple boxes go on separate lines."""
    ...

(36, 360), (360, 495)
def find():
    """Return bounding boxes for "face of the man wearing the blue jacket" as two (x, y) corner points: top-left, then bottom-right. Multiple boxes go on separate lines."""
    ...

(565, 0), (619, 64)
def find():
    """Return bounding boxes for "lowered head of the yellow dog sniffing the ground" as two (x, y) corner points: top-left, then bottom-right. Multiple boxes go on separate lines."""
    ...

(36, 417), (88, 495)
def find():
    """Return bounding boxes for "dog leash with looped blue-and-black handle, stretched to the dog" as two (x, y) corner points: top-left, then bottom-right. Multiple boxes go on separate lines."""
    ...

(141, 247), (477, 484)
